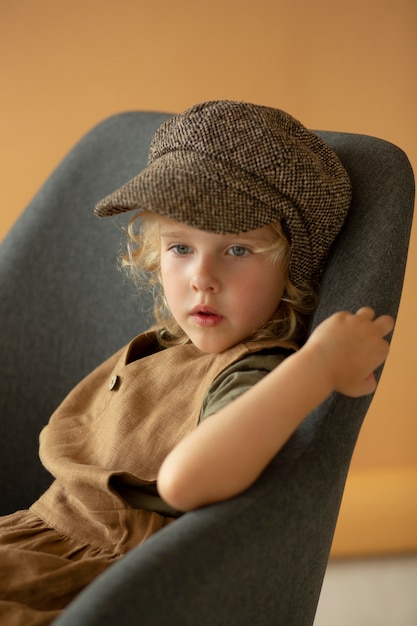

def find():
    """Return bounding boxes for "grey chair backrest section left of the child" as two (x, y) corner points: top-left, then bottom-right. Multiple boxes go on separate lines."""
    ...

(0, 112), (169, 513)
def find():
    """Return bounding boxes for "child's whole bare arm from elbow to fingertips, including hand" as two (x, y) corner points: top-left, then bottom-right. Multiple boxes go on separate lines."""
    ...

(158, 308), (393, 511)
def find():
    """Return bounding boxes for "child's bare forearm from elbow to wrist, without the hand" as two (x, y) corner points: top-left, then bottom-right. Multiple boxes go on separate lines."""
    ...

(158, 346), (332, 511)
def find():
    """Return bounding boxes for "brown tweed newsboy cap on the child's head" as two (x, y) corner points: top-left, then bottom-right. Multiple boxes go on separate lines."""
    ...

(95, 100), (351, 286)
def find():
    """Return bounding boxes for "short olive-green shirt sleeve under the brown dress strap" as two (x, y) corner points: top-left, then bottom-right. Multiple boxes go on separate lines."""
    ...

(199, 352), (288, 423)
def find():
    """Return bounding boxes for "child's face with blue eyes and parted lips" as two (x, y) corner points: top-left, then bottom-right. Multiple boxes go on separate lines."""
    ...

(160, 220), (284, 353)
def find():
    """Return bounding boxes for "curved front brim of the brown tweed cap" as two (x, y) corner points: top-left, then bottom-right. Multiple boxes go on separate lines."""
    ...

(95, 152), (312, 279)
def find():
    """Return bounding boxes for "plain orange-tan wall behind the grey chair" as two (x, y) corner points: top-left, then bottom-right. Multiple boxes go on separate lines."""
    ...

(0, 0), (417, 554)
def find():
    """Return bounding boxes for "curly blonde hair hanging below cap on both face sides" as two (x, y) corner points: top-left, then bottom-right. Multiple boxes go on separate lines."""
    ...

(121, 211), (317, 349)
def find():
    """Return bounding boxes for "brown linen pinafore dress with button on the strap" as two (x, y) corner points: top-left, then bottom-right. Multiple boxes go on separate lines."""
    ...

(0, 332), (285, 626)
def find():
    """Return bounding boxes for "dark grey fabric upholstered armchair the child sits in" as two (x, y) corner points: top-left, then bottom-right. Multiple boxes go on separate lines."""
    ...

(0, 112), (414, 626)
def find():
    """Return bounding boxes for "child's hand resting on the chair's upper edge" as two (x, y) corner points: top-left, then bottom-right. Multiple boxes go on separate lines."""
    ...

(305, 307), (394, 397)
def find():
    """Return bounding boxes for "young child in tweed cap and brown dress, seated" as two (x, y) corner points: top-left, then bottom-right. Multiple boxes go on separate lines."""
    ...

(0, 101), (393, 626)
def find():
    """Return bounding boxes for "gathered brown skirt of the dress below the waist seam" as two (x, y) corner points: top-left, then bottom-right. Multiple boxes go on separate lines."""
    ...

(0, 511), (115, 626)
